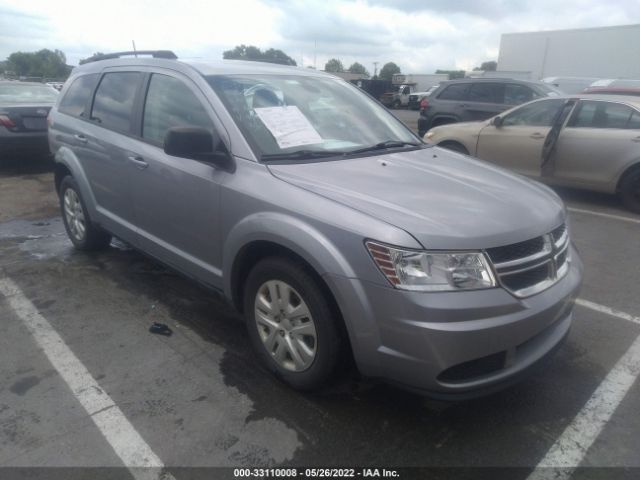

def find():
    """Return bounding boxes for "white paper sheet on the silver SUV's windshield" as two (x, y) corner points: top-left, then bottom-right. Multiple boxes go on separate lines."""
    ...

(254, 105), (322, 148)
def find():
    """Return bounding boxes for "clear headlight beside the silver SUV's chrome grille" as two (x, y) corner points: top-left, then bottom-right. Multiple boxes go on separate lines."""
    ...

(366, 241), (496, 292)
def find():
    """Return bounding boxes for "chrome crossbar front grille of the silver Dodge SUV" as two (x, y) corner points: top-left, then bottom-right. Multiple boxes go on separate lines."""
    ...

(486, 224), (570, 298)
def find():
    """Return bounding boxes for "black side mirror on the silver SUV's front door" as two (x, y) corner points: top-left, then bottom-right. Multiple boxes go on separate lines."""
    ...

(164, 127), (231, 167)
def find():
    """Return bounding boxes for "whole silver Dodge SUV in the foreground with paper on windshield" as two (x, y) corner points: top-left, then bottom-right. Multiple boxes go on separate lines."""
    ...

(49, 52), (582, 397)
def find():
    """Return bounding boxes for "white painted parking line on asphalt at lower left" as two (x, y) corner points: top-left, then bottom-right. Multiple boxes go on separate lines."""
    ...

(0, 278), (172, 480)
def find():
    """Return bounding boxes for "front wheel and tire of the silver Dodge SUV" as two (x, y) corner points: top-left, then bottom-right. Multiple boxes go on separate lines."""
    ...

(243, 257), (344, 391)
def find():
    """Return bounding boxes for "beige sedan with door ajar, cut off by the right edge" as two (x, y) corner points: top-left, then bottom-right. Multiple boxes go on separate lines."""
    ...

(425, 94), (640, 213)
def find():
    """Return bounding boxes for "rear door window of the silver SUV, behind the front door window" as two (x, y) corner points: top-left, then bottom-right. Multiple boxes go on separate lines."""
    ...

(91, 72), (142, 132)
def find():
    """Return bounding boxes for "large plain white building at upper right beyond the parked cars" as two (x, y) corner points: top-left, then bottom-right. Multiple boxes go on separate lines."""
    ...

(498, 25), (640, 79)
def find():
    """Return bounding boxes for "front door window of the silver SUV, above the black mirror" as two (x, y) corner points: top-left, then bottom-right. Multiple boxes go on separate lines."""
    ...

(142, 74), (213, 144)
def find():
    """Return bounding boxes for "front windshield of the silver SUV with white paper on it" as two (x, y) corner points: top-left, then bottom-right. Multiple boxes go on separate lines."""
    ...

(207, 75), (422, 160)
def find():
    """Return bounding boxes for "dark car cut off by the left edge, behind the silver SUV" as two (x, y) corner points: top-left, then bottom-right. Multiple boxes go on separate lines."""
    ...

(0, 81), (58, 157)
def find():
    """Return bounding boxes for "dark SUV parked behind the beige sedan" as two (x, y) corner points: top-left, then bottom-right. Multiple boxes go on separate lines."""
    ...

(418, 78), (561, 136)
